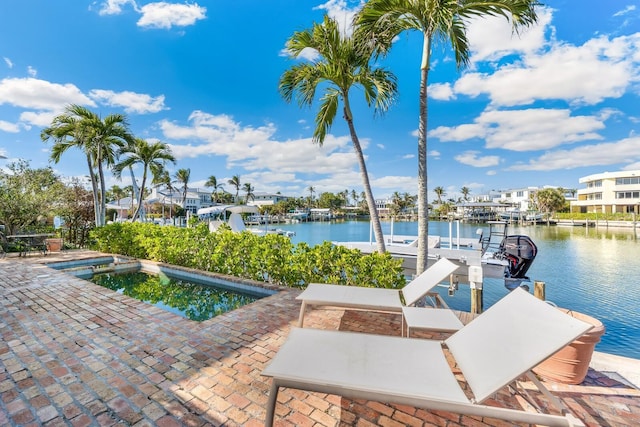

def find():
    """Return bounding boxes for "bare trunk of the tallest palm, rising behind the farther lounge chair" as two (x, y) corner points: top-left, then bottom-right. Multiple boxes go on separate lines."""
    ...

(416, 34), (431, 275)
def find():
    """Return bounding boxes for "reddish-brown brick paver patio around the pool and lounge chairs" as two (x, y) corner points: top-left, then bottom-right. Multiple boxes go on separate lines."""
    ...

(0, 253), (640, 426)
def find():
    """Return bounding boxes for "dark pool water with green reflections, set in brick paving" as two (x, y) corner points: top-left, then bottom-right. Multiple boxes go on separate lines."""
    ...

(87, 272), (259, 322)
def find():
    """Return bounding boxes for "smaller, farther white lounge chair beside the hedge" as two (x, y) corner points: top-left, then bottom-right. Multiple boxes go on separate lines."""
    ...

(296, 258), (458, 327)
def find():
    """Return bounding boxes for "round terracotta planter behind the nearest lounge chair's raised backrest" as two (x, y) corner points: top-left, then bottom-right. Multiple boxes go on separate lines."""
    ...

(533, 308), (604, 384)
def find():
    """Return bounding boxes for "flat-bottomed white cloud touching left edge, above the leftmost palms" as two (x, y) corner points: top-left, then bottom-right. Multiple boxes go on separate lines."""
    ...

(0, 77), (96, 111)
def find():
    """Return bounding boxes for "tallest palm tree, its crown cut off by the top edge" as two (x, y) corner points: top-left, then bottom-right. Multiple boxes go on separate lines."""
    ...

(355, 0), (538, 274)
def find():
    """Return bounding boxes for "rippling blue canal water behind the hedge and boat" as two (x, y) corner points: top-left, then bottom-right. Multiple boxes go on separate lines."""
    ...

(278, 221), (640, 359)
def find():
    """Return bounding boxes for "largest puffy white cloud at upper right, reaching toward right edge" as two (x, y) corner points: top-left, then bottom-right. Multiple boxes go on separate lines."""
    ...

(453, 33), (640, 106)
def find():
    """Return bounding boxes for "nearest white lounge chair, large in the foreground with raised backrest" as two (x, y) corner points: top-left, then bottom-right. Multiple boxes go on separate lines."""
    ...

(262, 289), (592, 426)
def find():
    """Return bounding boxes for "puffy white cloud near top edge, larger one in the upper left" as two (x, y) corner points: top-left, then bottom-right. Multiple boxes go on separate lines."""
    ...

(138, 2), (207, 29)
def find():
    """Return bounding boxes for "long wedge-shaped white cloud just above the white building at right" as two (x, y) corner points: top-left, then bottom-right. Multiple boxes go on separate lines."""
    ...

(508, 137), (640, 171)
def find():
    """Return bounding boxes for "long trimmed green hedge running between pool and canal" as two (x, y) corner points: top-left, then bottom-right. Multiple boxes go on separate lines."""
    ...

(91, 223), (406, 288)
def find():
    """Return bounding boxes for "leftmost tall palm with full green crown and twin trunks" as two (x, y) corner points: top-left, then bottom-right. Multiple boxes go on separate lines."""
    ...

(40, 104), (133, 226)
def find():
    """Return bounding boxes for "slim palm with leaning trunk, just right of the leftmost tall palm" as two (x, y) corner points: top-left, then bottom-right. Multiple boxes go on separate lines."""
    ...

(113, 138), (176, 222)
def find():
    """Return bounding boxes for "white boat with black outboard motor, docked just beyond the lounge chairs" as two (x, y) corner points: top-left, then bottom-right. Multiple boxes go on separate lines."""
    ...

(333, 221), (538, 289)
